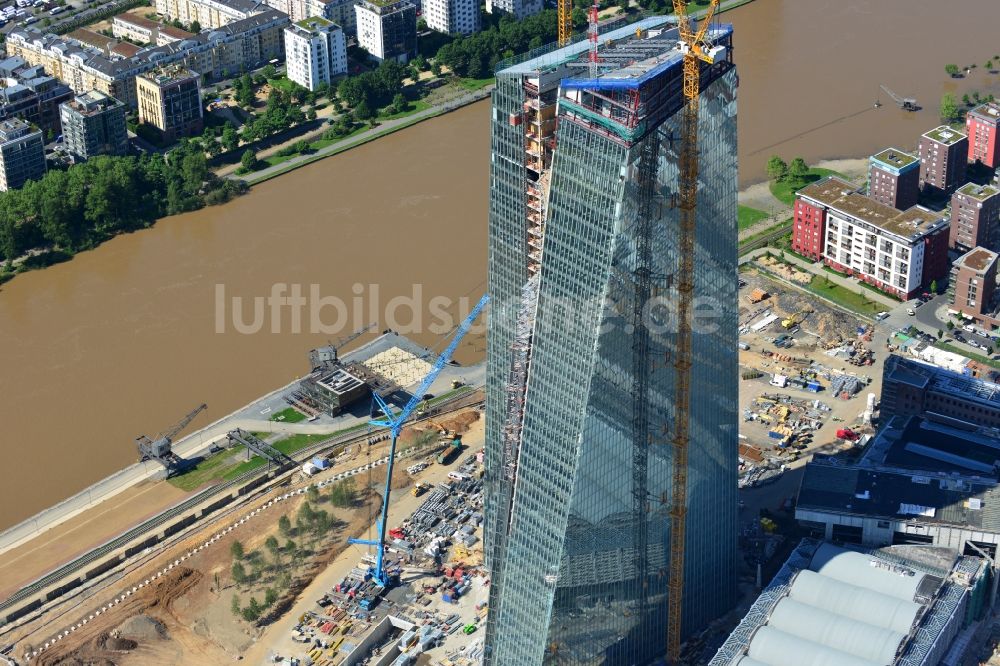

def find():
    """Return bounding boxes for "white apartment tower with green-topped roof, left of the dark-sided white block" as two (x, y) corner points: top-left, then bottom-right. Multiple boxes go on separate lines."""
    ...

(285, 16), (347, 90)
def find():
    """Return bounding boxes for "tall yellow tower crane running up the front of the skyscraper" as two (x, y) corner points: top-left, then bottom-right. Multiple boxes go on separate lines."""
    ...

(667, 0), (719, 663)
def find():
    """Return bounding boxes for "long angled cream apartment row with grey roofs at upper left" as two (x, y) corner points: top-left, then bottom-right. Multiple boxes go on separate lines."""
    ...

(5, 9), (288, 108)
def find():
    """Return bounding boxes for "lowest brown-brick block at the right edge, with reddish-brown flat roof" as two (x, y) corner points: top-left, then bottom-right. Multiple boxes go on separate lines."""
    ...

(948, 247), (1000, 330)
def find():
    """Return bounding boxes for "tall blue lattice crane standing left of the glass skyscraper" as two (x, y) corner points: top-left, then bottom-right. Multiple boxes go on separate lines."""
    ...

(348, 294), (490, 588)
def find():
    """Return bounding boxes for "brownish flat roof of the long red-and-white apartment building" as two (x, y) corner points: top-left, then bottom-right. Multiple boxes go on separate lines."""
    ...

(798, 176), (945, 239)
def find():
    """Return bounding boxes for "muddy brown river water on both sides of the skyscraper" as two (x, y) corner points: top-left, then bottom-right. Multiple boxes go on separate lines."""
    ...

(0, 0), (1000, 529)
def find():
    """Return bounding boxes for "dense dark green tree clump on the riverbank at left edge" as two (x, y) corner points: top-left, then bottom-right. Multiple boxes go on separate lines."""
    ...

(0, 142), (245, 269)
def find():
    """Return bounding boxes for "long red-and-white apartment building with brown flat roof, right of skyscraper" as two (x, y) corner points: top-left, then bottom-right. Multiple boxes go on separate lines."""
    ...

(792, 176), (948, 300)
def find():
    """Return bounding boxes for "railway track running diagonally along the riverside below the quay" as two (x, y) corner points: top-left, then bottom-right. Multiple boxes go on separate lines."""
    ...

(0, 390), (484, 614)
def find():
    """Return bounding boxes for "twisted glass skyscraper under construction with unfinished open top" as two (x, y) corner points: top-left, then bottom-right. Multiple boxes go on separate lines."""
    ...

(486, 17), (737, 666)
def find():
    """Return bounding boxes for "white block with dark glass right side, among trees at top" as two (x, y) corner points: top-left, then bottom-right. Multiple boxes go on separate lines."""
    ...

(354, 0), (417, 64)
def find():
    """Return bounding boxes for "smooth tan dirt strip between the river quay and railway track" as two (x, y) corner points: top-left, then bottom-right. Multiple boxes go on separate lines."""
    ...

(0, 481), (186, 598)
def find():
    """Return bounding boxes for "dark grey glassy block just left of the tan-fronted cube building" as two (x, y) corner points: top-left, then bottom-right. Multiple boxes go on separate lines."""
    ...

(59, 90), (128, 160)
